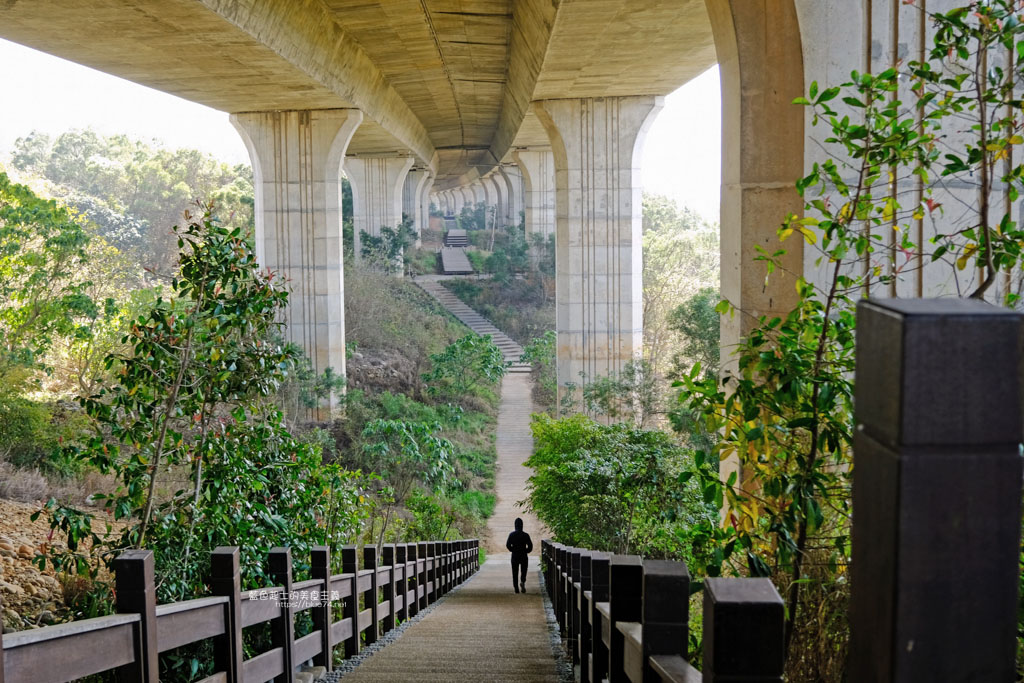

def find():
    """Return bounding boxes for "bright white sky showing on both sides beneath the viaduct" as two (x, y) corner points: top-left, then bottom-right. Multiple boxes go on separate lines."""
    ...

(0, 40), (721, 220)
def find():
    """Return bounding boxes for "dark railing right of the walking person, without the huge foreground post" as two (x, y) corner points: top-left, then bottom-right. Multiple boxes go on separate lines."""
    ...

(541, 541), (783, 683)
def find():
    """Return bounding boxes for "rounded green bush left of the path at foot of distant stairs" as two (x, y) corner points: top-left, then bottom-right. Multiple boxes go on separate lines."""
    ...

(423, 334), (508, 398)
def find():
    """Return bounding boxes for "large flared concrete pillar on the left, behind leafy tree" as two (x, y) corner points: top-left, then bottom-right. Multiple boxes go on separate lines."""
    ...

(230, 110), (362, 402)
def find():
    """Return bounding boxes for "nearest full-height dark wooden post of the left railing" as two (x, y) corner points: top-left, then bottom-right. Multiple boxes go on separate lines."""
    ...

(114, 550), (160, 683)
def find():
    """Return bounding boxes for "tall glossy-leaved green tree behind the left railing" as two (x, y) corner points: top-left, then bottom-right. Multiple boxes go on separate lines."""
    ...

(34, 202), (367, 614)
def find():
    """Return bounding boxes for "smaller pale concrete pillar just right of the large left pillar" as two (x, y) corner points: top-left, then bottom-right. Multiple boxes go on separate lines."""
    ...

(345, 157), (415, 255)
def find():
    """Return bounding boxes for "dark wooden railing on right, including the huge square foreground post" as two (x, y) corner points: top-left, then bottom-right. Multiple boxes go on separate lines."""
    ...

(543, 299), (1024, 683)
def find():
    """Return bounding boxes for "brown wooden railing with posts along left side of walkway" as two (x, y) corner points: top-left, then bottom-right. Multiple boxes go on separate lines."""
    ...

(0, 540), (479, 683)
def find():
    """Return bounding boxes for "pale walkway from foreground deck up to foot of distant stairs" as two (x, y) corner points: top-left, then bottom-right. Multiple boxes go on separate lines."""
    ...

(344, 292), (560, 683)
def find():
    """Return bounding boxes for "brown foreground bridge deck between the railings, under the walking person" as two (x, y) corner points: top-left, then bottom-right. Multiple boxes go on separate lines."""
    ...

(342, 557), (560, 683)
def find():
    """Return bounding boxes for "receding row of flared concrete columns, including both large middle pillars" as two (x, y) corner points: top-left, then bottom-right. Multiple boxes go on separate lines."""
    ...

(231, 96), (660, 409)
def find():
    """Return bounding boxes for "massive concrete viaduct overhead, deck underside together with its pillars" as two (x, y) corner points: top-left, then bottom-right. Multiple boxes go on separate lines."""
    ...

(0, 0), (951, 395)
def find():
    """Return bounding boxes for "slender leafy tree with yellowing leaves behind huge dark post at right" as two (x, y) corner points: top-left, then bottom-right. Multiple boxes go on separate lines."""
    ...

(681, 5), (1024, 680)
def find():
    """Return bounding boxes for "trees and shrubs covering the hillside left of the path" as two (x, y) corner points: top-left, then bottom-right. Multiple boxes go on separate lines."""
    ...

(0, 132), (504, 667)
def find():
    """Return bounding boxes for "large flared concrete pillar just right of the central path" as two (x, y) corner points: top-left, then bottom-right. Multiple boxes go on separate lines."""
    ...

(534, 95), (664, 405)
